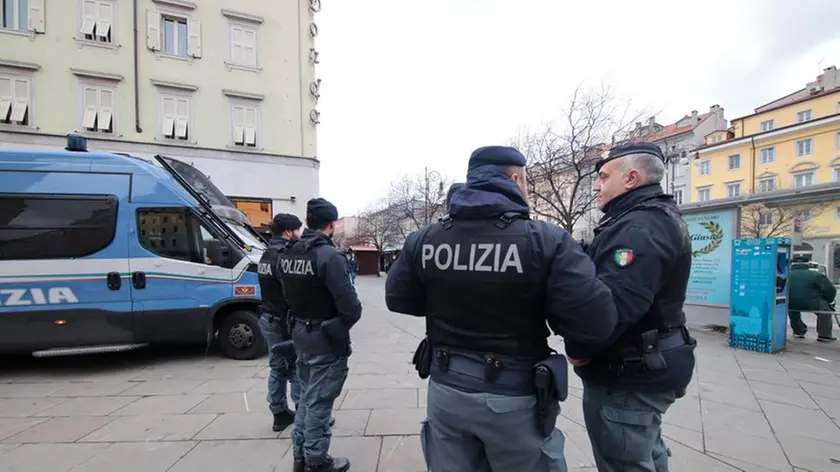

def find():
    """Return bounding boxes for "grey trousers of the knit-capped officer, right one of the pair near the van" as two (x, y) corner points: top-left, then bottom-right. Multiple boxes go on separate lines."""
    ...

(292, 350), (348, 465)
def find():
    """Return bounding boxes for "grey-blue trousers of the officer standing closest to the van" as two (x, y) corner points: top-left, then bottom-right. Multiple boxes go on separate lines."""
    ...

(260, 315), (300, 414)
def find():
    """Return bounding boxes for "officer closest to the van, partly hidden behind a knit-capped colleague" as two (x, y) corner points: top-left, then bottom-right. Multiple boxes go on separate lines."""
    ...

(257, 213), (303, 431)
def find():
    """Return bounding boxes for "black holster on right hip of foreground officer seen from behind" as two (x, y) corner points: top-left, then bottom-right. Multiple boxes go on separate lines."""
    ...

(534, 354), (569, 437)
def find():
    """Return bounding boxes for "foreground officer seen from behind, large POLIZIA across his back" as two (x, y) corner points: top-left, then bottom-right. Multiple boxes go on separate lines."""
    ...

(385, 146), (616, 472)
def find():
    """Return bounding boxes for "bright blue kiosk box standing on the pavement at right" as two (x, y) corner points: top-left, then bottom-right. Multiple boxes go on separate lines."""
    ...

(729, 238), (791, 352)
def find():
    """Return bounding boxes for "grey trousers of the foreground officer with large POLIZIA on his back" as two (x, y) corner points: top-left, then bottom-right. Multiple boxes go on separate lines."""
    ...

(420, 380), (566, 472)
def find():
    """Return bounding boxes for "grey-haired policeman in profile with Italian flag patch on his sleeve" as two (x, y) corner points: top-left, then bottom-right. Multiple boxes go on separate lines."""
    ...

(566, 143), (696, 472)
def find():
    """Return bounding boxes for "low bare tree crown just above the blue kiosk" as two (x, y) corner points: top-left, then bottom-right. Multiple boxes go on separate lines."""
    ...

(741, 203), (827, 238)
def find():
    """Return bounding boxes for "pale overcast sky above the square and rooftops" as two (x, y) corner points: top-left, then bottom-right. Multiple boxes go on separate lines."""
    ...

(315, 0), (840, 216)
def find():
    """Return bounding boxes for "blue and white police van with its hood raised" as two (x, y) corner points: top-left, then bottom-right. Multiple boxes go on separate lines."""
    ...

(0, 135), (265, 360)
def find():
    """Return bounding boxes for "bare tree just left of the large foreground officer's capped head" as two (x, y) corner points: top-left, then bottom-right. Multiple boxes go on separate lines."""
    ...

(388, 169), (452, 239)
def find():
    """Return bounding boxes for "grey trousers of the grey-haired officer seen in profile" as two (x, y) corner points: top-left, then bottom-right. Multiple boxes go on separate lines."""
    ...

(583, 382), (677, 472)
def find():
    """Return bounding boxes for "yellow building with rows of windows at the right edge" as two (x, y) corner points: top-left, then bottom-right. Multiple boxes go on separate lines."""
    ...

(691, 67), (840, 262)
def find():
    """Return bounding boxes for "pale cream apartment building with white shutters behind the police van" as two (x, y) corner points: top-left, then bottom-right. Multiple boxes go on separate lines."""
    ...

(0, 0), (321, 230)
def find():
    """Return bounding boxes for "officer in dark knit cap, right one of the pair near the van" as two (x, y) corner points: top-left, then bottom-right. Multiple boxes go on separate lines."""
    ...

(280, 198), (362, 472)
